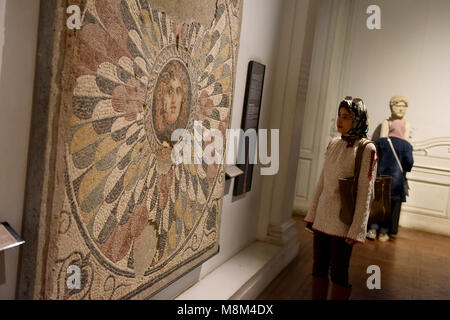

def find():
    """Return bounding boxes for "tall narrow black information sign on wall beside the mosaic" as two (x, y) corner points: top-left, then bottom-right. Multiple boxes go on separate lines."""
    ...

(233, 61), (266, 196)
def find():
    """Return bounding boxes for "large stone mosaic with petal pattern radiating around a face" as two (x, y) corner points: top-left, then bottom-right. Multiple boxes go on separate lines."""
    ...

(19, 0), (241, 299)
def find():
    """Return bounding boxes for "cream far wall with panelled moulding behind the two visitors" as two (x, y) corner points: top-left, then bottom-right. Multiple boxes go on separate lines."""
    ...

(295, 0), (450, 234)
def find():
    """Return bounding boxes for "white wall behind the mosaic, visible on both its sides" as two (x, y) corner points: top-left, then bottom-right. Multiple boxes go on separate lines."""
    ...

(0, 0), (294, 299)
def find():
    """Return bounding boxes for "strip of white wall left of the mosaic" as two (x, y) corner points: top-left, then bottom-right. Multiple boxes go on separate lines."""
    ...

(0, 0), (39, 299)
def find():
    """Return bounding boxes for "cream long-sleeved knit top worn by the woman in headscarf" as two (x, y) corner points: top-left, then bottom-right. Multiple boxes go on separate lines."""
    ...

(305, 138), (377, 243)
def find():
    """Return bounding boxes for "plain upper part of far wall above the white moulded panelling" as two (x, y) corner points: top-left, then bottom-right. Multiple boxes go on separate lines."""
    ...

(343, 0), (450, 142)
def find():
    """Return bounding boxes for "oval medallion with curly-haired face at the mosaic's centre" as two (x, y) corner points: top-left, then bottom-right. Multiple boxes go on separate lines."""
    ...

(152, 60), (192, 142)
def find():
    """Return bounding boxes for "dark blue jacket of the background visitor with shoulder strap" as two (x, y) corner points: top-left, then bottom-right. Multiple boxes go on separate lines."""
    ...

(376, 138), (414, 202)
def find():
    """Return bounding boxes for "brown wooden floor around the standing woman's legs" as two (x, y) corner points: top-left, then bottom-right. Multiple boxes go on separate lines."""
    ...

(258, 217), (450, 300)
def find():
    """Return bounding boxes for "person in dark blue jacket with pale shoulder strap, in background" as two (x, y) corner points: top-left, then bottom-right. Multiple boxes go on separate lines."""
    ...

(367, 120), (414, 242)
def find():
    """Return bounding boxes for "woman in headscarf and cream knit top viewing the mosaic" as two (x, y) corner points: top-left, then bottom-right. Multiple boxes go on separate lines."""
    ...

(305, 97), (377, 300)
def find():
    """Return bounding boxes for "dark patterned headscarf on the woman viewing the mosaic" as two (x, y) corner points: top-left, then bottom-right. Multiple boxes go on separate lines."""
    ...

(339, 97), (369, 139)
